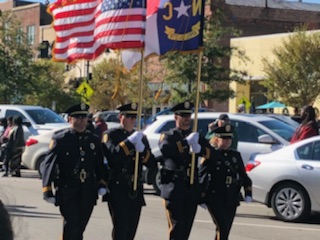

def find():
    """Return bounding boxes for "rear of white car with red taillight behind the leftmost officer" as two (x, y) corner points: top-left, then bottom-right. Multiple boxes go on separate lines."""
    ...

(21, 125), (70, 173)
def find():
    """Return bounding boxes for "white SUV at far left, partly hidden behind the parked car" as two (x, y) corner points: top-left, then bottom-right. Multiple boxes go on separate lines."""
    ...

(0, 105), (69, 140)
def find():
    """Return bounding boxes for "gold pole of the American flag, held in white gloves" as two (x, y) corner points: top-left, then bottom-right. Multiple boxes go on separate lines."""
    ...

(133, 49), (143, 192)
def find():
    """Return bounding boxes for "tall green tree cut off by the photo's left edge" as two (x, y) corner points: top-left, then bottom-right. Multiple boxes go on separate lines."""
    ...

(0, 11), (33, 103)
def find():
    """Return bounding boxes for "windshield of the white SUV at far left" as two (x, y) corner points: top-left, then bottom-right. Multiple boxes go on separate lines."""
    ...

(26, 109), (66, 124)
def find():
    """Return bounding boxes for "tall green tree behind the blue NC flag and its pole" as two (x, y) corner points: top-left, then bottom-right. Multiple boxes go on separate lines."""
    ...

(160, 10), (246, 102)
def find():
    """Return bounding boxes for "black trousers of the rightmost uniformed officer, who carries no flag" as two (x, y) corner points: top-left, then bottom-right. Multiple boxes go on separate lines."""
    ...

(206, 196), (238, 240)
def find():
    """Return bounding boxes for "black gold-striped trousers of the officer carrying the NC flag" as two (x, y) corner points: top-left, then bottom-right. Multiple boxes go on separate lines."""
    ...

(165, 198), (198, 240)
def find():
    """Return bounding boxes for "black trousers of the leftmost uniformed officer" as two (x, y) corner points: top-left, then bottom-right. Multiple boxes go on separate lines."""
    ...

(60, 197), (95, 240)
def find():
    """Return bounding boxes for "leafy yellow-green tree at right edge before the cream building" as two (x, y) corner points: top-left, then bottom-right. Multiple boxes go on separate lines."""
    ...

(263, 27), (320, 107)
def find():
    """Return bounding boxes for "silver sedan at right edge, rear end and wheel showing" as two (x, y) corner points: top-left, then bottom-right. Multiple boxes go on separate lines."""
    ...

(246, 136), (320, 222)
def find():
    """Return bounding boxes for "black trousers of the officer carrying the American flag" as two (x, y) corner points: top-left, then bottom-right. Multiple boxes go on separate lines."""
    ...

(108, 201), (142, 240)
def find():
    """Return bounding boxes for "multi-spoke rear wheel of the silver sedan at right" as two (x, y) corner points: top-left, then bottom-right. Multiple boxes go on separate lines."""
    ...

(271, 183), (311, 222)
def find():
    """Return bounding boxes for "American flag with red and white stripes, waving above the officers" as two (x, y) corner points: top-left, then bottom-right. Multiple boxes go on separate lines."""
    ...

(49, 0), (146, 63)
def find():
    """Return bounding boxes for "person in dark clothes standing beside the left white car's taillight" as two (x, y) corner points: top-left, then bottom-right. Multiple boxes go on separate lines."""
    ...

(4, 116), (25, 177)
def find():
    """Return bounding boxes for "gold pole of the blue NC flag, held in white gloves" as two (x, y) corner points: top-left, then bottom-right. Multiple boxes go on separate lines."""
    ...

(190, 49), (203, 185)
